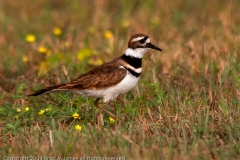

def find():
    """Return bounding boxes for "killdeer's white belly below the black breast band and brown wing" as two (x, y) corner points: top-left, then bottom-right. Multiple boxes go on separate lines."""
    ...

(74, 73), (139, 102)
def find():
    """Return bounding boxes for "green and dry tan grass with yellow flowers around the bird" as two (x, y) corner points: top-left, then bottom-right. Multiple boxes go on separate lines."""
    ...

(0, 0), (240, 159)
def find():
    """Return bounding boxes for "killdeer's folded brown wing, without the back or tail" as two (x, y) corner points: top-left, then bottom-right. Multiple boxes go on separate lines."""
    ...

(58, 68), (127, 90)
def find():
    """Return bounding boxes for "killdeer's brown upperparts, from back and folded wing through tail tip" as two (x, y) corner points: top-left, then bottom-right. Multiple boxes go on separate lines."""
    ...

(29, 58), (127, 96)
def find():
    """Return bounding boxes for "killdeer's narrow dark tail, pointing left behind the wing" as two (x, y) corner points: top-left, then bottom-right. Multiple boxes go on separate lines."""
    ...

(28, 84), (67, 96)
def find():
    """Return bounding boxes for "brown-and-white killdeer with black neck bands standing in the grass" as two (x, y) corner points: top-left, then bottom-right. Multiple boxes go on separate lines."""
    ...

(29, 34), (162, 120)
